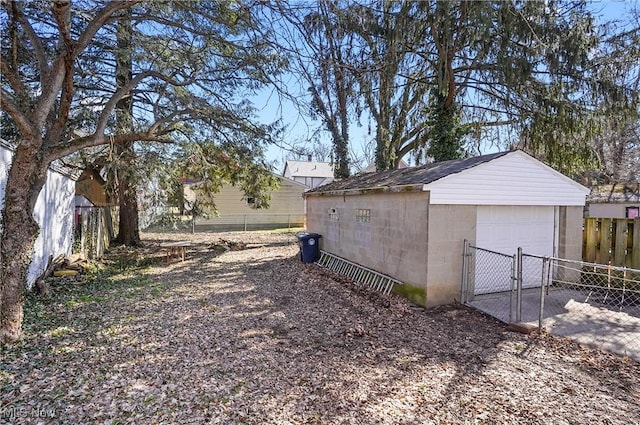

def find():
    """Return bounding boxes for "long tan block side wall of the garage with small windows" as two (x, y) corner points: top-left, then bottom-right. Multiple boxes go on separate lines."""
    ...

(307, 192), (429, 287)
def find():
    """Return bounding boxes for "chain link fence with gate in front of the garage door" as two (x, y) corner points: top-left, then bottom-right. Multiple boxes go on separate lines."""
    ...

(462, 242), (640, 361)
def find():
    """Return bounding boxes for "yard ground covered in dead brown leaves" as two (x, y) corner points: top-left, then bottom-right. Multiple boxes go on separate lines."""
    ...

(0, 232), (640, 425)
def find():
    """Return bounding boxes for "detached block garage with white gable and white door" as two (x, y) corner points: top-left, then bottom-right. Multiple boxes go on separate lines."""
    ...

(305, 151), (589, 306)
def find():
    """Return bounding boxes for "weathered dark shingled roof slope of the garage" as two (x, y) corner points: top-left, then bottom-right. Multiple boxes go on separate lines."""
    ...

(307, 151), (510, 193)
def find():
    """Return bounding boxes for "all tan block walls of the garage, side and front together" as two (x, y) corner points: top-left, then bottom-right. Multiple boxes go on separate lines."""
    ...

(307, 192), (582, 307)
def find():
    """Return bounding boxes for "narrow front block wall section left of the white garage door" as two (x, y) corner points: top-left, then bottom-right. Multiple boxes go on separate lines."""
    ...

(427, 205), (477, 307)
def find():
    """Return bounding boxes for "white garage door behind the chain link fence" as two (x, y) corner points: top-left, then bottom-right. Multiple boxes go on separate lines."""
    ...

(475, 206), (556, 294)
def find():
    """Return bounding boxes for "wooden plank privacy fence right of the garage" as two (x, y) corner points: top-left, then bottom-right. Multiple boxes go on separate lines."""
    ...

(582, 217), (640, 269)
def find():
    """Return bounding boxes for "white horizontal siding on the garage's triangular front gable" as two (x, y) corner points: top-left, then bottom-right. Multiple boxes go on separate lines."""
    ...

(424, 151), (589, 206)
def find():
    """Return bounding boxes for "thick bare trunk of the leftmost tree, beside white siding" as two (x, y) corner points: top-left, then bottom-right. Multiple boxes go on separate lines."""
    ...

(0, 141), (47, 344)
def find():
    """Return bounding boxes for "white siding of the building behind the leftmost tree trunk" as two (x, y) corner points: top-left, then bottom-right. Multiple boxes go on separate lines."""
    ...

(0, 146), (75, 288)
